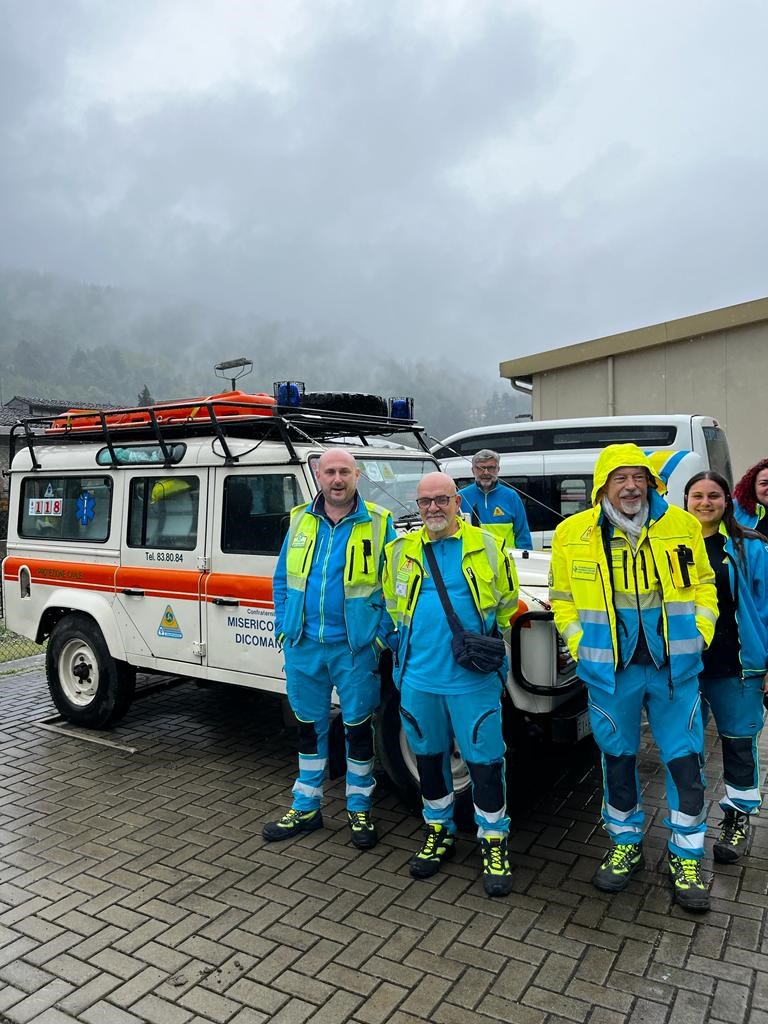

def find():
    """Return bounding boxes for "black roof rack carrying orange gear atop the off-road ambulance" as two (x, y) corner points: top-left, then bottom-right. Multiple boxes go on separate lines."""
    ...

(10, 395), (429, 470)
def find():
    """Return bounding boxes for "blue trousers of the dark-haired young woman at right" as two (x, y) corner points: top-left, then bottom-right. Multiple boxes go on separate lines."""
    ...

(699, 676), (763, 814)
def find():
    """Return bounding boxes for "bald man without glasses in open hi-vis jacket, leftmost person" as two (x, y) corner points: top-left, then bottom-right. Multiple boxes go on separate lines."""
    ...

(262, 449), (395, 850)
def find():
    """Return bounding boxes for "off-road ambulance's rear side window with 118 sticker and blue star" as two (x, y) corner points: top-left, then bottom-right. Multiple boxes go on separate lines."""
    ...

(18, 476), (112, 544)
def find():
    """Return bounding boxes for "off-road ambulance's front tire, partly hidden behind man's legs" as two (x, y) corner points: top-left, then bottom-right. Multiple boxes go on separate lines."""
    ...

(376, 686), (476, 831)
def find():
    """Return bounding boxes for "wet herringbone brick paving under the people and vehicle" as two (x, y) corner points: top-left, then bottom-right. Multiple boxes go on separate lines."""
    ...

(0, 669), (768, 1024)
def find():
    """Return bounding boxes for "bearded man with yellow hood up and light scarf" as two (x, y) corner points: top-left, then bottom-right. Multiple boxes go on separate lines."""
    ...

(550, 444), (717, 910)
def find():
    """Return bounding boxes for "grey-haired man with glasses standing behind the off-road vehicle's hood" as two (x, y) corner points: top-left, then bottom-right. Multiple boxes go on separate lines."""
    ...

(459, 449), (534, 551)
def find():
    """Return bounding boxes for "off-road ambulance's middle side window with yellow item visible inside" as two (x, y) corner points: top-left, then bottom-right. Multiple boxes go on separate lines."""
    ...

(128, 476), (200, 551)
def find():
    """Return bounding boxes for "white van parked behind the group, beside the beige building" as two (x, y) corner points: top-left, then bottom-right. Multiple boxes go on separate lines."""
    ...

(432, 413), (733, 548)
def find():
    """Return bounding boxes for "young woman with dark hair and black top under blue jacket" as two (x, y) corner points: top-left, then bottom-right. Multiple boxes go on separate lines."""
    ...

(685, 471), (768, 863)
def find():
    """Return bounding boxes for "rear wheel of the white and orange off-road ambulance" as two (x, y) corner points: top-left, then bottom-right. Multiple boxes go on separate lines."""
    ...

(45, 612), (136, 729)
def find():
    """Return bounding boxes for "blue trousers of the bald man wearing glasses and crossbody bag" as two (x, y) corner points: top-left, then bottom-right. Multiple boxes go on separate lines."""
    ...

(400, 675), (509, 838)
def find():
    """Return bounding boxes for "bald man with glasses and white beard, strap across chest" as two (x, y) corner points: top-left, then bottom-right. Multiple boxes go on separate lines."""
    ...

(384, 473), (517, 896)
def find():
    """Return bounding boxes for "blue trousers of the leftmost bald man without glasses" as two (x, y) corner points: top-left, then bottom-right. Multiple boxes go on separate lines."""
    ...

(284, 637), (380, 812)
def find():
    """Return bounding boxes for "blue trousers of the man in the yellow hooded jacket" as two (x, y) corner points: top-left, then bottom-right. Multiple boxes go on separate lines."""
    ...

(589, 665), (707, 859)
